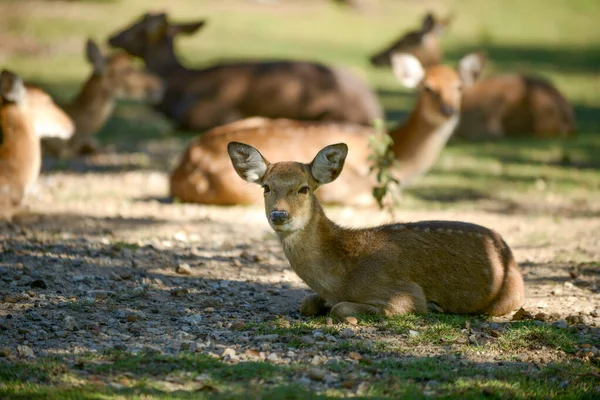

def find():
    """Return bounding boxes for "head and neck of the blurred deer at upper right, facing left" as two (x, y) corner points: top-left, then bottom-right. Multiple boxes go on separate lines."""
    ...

(369, 12), (453, 67)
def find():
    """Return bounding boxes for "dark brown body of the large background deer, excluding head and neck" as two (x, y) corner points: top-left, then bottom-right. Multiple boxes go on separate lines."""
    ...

(158, 61), (382, 131)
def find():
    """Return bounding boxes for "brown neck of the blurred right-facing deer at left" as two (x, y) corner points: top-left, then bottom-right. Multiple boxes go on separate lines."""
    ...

(65, 74), (115, 136)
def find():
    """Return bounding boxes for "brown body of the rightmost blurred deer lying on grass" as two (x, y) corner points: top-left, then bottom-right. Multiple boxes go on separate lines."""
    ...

(454, 74), (576, 140)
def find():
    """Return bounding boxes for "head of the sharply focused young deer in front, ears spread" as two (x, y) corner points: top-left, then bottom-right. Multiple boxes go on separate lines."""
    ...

(227, 142), (348, 234)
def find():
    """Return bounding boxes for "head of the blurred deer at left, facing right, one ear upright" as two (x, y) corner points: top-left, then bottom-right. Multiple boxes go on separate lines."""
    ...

(85, 39), (164, 103)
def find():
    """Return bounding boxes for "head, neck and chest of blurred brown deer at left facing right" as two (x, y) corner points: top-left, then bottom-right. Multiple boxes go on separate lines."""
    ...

(43, 40), (164, 157)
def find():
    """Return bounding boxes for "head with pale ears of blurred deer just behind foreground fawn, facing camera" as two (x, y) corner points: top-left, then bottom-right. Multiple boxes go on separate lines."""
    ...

(392, 53), (485, 125)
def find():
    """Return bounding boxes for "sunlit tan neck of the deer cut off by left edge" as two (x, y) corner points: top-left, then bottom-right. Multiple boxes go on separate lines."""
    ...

(0, 104), (42, 191)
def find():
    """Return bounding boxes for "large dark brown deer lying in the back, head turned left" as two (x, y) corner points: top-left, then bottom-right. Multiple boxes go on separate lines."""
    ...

(108, 13), (382, 132)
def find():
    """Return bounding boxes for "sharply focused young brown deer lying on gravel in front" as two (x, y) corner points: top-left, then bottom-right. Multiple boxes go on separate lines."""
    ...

(227, 142), (524, 319)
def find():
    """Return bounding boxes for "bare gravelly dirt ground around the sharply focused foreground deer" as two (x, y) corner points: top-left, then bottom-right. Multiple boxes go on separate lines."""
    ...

(0, 166), (600, 396)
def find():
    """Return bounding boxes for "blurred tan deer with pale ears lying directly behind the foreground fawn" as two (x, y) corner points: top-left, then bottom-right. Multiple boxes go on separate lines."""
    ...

(170, 53), (485, 207)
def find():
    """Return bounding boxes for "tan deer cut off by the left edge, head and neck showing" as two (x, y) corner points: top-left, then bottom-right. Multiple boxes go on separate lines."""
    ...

(0, 70), (42, 218)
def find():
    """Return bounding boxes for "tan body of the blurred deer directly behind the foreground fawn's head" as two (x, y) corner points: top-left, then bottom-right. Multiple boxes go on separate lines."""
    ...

(171, 119), (372, 204)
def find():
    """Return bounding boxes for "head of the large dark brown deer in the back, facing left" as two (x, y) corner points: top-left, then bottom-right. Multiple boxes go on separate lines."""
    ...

(108, 13), (205, 58)
